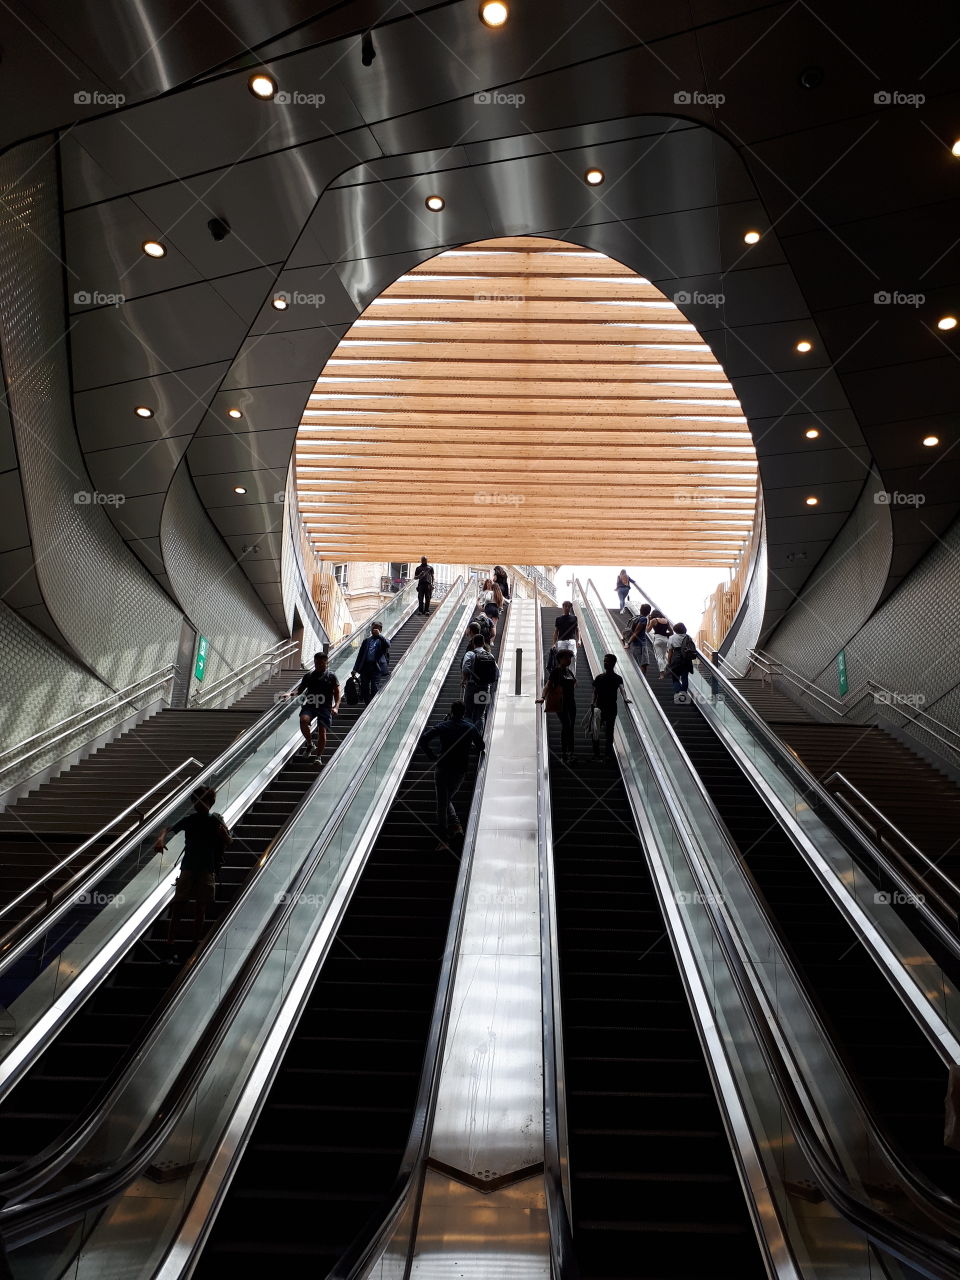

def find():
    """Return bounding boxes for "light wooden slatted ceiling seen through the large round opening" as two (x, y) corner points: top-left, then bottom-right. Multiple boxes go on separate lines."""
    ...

(297, 237), (756, 568)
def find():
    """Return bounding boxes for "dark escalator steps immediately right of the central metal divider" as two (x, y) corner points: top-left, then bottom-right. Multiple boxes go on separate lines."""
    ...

(543, 611), (765, 1280)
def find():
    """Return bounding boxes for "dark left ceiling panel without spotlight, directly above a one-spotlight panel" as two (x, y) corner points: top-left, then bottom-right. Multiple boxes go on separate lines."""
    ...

(70, 284), (253, 390)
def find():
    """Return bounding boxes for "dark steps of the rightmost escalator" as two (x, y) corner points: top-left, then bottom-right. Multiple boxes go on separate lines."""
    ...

(632, 614), (960, 1197)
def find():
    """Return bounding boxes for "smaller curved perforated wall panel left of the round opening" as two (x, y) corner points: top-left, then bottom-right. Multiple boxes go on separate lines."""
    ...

(160, 466), (280, 701)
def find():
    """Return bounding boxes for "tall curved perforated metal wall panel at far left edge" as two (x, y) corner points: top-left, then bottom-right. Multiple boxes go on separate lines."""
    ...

(0, 140), (180, 689)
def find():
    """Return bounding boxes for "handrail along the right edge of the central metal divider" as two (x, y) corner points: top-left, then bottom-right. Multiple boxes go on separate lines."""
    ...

(534, 586), (580, 1280)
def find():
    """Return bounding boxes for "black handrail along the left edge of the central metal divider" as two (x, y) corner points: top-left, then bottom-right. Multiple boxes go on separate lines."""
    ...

(325, 604), (512, 1280)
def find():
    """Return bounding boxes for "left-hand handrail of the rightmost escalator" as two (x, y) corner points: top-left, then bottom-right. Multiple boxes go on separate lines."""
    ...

(580, 582), (960, 1280)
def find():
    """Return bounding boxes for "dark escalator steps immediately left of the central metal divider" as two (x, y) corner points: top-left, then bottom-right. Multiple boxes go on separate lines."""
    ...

(193, 614), (499, 1277)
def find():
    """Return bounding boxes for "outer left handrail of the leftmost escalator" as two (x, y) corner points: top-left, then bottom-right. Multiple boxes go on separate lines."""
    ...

(0, 581), (424, 974)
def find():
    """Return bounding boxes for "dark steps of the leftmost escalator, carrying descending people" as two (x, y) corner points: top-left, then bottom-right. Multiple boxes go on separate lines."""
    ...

(0, 613), (426, 1172)
